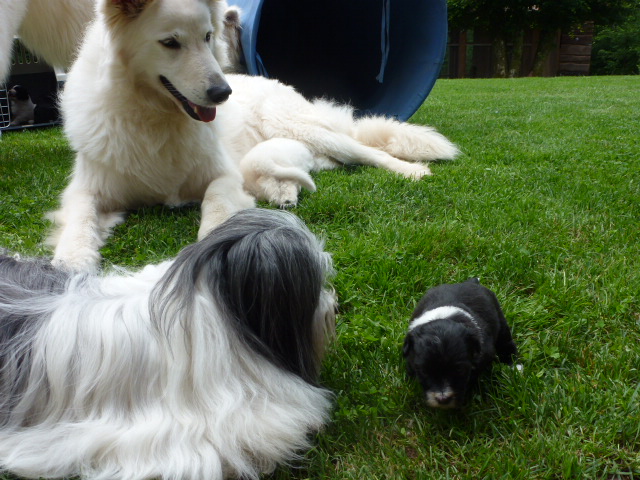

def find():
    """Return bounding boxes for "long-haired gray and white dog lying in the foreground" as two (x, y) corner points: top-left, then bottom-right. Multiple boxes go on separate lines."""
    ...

(0, 209), (335, 480)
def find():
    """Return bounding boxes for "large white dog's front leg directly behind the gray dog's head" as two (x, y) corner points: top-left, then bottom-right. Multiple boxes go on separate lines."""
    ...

(198, 172), (255, 240)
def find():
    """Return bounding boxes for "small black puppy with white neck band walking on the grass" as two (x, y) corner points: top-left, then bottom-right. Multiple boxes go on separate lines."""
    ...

(403, 278), (517, 408)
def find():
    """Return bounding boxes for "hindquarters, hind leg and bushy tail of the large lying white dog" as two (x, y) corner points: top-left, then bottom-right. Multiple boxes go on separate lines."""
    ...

(220, 75), (459, 188)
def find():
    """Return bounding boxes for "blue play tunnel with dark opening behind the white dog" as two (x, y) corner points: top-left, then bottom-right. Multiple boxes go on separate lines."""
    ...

(230, 0), (447, 120)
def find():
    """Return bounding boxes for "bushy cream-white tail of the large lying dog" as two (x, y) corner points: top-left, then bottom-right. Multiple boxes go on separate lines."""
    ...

(354, 117), (460, 162)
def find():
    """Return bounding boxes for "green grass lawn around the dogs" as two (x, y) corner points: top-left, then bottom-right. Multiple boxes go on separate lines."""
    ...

(0, 77), (640, 480)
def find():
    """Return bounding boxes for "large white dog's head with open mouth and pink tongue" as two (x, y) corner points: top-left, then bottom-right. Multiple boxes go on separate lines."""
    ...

(101, 0), (231, 122)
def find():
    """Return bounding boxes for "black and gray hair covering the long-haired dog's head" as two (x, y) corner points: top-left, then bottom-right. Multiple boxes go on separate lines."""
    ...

(153, 209), (331, 383)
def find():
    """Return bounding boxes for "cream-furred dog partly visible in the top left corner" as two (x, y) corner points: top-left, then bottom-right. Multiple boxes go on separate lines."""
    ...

(0, 0), (95, 83)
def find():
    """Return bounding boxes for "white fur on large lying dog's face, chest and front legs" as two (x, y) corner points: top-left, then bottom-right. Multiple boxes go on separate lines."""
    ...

(52, 0), (254, 270)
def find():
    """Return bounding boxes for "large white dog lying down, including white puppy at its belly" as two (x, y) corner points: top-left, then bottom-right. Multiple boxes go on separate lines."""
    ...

(52, 0), (458, 270)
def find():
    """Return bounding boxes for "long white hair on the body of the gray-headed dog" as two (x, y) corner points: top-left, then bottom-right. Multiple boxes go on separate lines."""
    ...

(0, 262), (330, 480)
